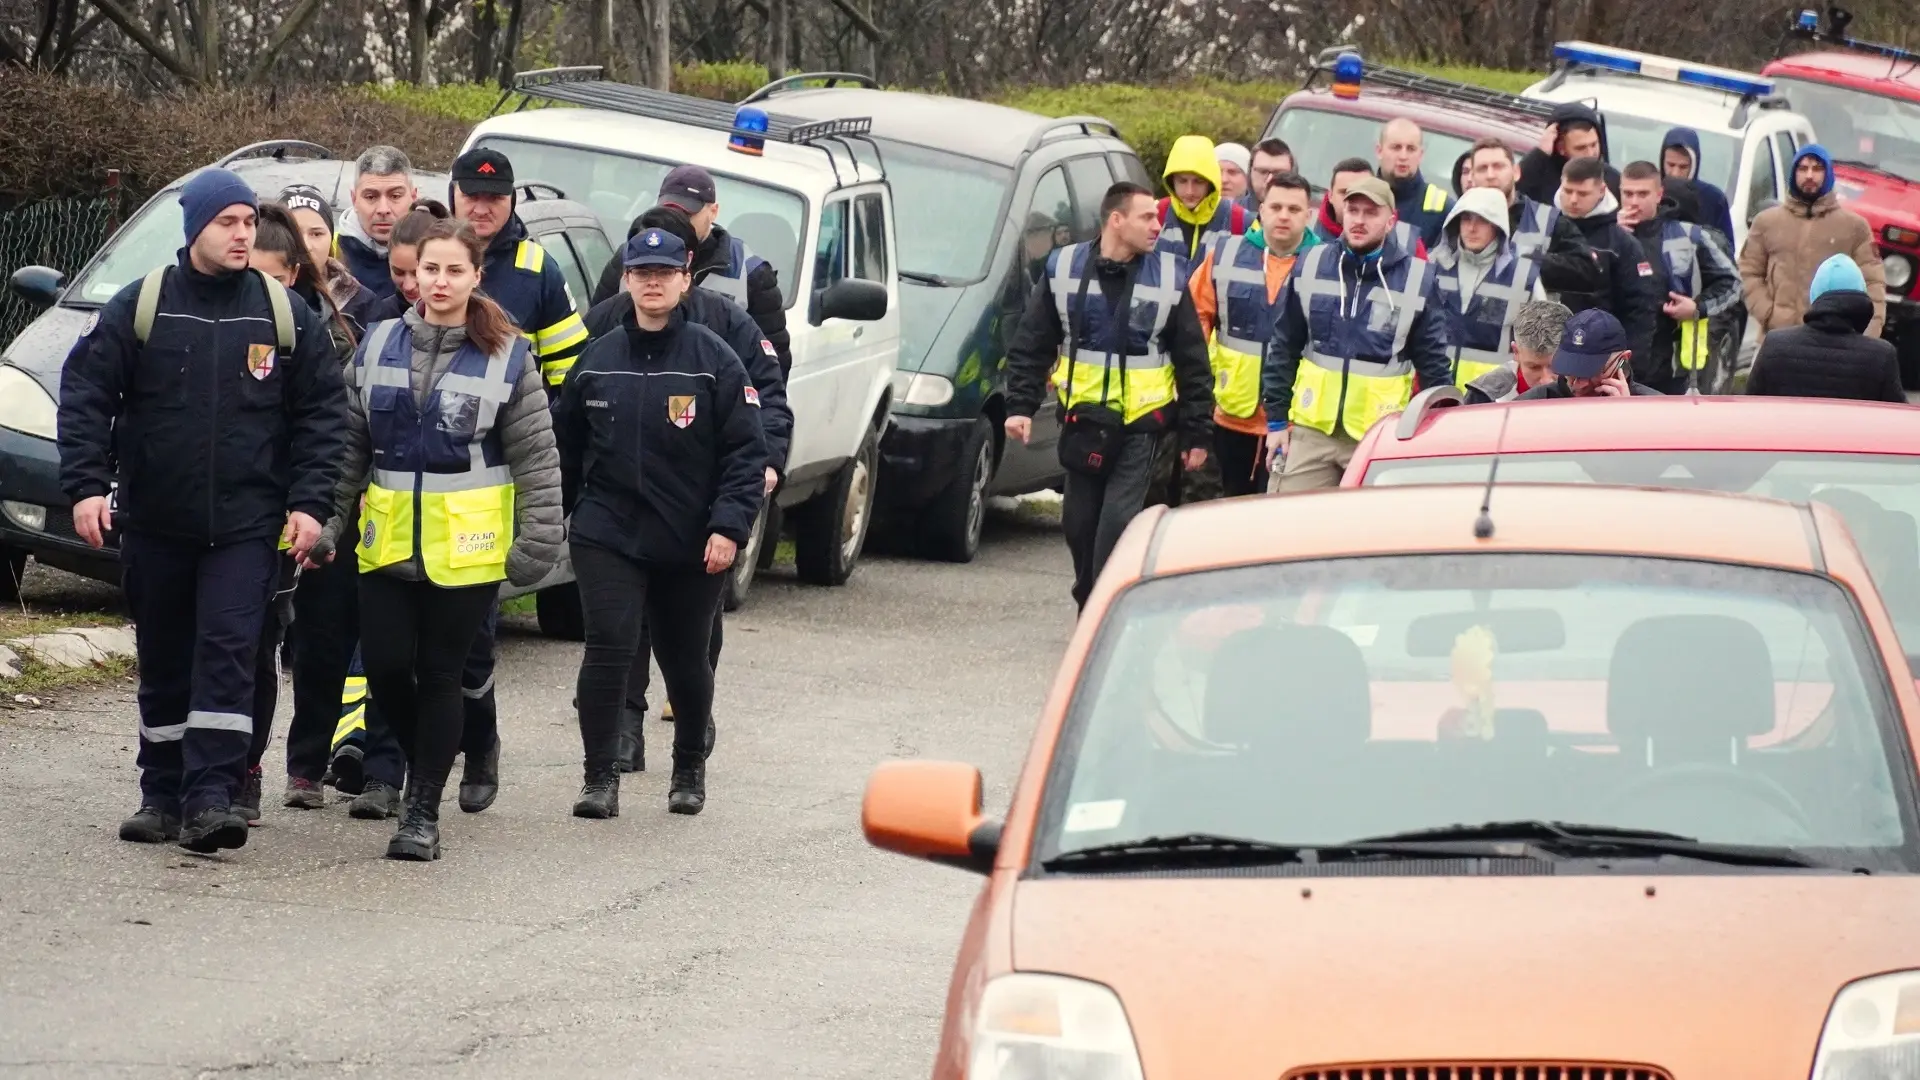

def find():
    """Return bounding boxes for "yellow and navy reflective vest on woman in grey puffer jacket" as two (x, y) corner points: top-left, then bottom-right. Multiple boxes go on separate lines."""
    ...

(353, 319), (530, 588)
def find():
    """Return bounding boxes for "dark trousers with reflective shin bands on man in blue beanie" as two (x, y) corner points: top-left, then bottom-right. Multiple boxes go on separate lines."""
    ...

(121, 532), (278, 817)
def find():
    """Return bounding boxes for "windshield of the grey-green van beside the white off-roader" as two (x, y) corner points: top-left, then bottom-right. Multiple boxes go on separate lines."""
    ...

(874, 138), (1014, 284)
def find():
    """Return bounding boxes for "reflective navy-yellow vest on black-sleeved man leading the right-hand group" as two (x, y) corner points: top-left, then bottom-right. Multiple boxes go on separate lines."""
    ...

(1048, 244), (1183, 423)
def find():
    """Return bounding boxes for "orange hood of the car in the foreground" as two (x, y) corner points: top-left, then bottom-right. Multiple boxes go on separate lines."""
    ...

(1012, 872), (1920, 1080)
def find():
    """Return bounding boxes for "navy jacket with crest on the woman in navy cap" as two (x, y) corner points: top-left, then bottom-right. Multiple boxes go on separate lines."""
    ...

(553, 307), (766, 565)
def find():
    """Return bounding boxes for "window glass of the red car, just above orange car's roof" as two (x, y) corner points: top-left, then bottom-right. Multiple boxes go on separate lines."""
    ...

(1363, 450), (1920, 659)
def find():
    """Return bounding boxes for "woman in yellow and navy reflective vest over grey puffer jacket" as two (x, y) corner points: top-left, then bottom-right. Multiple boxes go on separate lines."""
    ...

(323, 221), (564, 861)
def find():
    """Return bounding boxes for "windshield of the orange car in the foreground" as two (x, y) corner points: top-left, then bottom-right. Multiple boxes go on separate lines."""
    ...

(1037, 553), (1914, 869)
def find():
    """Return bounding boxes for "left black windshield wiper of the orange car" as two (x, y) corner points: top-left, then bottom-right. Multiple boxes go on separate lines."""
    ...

(1041, 832), (1538, 871)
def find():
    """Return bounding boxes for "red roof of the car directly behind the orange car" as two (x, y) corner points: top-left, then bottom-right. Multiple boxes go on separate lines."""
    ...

(1350, 398), (1920, 463)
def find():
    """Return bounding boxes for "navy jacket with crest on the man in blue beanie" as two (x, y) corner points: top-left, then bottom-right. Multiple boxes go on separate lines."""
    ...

(58, 250), (348, 544)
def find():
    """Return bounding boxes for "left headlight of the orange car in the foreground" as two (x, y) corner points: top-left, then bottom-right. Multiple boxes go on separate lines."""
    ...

(968, 974), (1140, 1080)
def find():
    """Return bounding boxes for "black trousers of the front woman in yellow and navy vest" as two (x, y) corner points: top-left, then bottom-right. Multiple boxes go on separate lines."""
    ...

(359, 573), (499, 784)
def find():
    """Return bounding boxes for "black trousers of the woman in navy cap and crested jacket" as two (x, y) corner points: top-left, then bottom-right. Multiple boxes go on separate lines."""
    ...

(572, 540), (726, 773)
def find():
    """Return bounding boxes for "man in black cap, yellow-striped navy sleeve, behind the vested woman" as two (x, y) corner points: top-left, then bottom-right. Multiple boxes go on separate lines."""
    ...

(447, 146), (588, 813)
